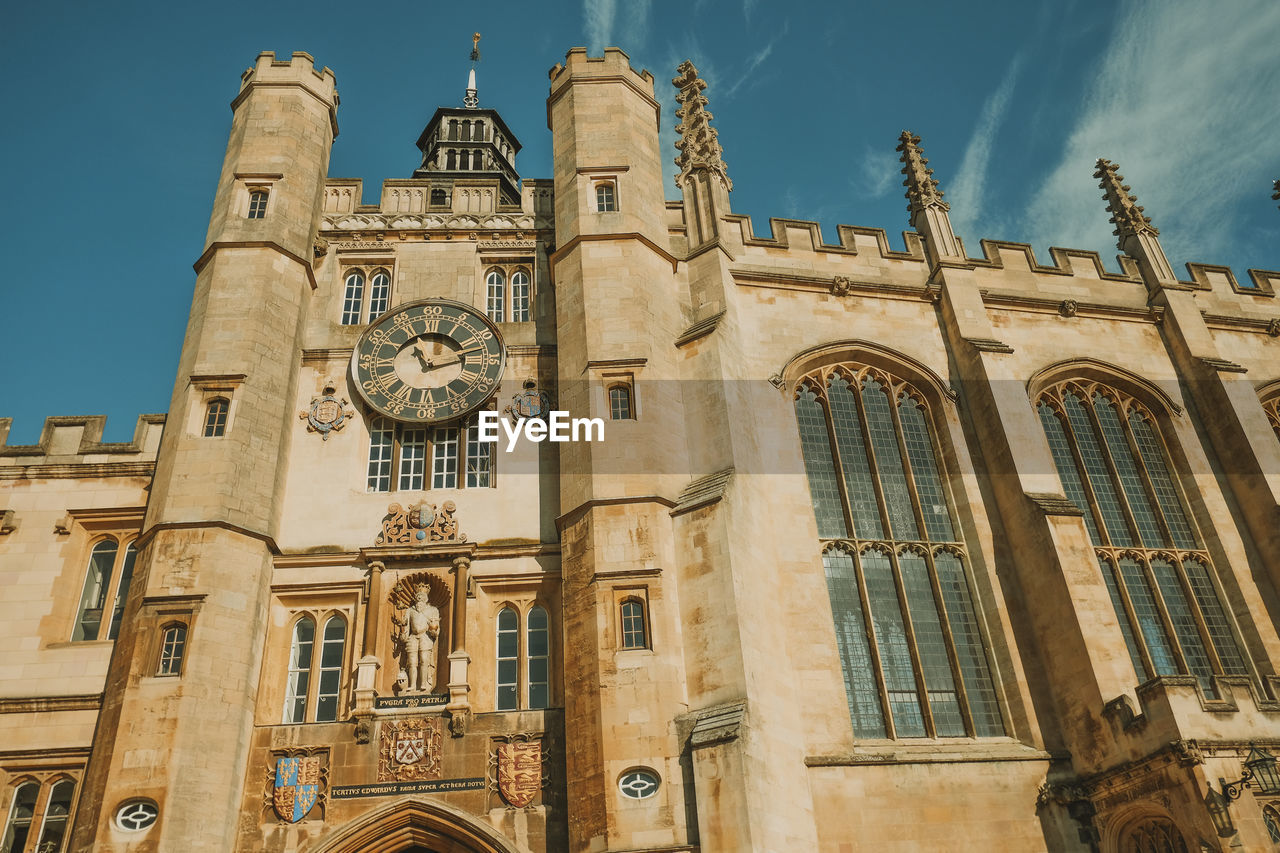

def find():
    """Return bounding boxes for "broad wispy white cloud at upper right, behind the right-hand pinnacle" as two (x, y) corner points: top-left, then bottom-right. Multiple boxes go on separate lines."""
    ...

(1027, 0), (1280, 263)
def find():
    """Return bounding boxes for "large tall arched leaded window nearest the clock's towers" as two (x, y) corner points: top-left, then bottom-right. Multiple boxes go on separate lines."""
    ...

(795, 365), (1005, 738)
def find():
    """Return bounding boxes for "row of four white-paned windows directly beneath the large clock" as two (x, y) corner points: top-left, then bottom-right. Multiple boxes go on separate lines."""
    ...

(365, 418), (494, 492)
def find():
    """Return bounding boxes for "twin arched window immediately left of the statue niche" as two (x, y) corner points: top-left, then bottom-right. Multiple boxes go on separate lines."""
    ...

(283, 613), (347, 722)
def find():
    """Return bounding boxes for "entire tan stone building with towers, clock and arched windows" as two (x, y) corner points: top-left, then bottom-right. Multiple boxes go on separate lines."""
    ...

(0, 49), (1280, 853)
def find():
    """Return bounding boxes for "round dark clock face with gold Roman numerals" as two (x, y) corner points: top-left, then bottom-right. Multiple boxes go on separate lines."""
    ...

(351, 300), (507, 424)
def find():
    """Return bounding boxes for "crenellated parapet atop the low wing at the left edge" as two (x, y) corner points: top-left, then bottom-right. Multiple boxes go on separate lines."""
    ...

(0, 415), (165, 469)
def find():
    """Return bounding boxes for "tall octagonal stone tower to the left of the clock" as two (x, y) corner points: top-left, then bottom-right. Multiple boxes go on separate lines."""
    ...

(70, 53), (338, 850)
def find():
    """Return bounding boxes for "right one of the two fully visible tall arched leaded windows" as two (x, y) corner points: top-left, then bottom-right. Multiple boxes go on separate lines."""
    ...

(1037, 380), (1249, 695)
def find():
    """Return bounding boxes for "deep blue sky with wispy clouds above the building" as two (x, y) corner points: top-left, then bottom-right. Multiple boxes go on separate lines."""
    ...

(0, 0), (1280, 444)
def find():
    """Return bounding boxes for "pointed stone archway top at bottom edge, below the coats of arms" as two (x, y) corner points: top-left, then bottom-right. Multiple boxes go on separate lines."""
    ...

(307, 799), (525, 853)
